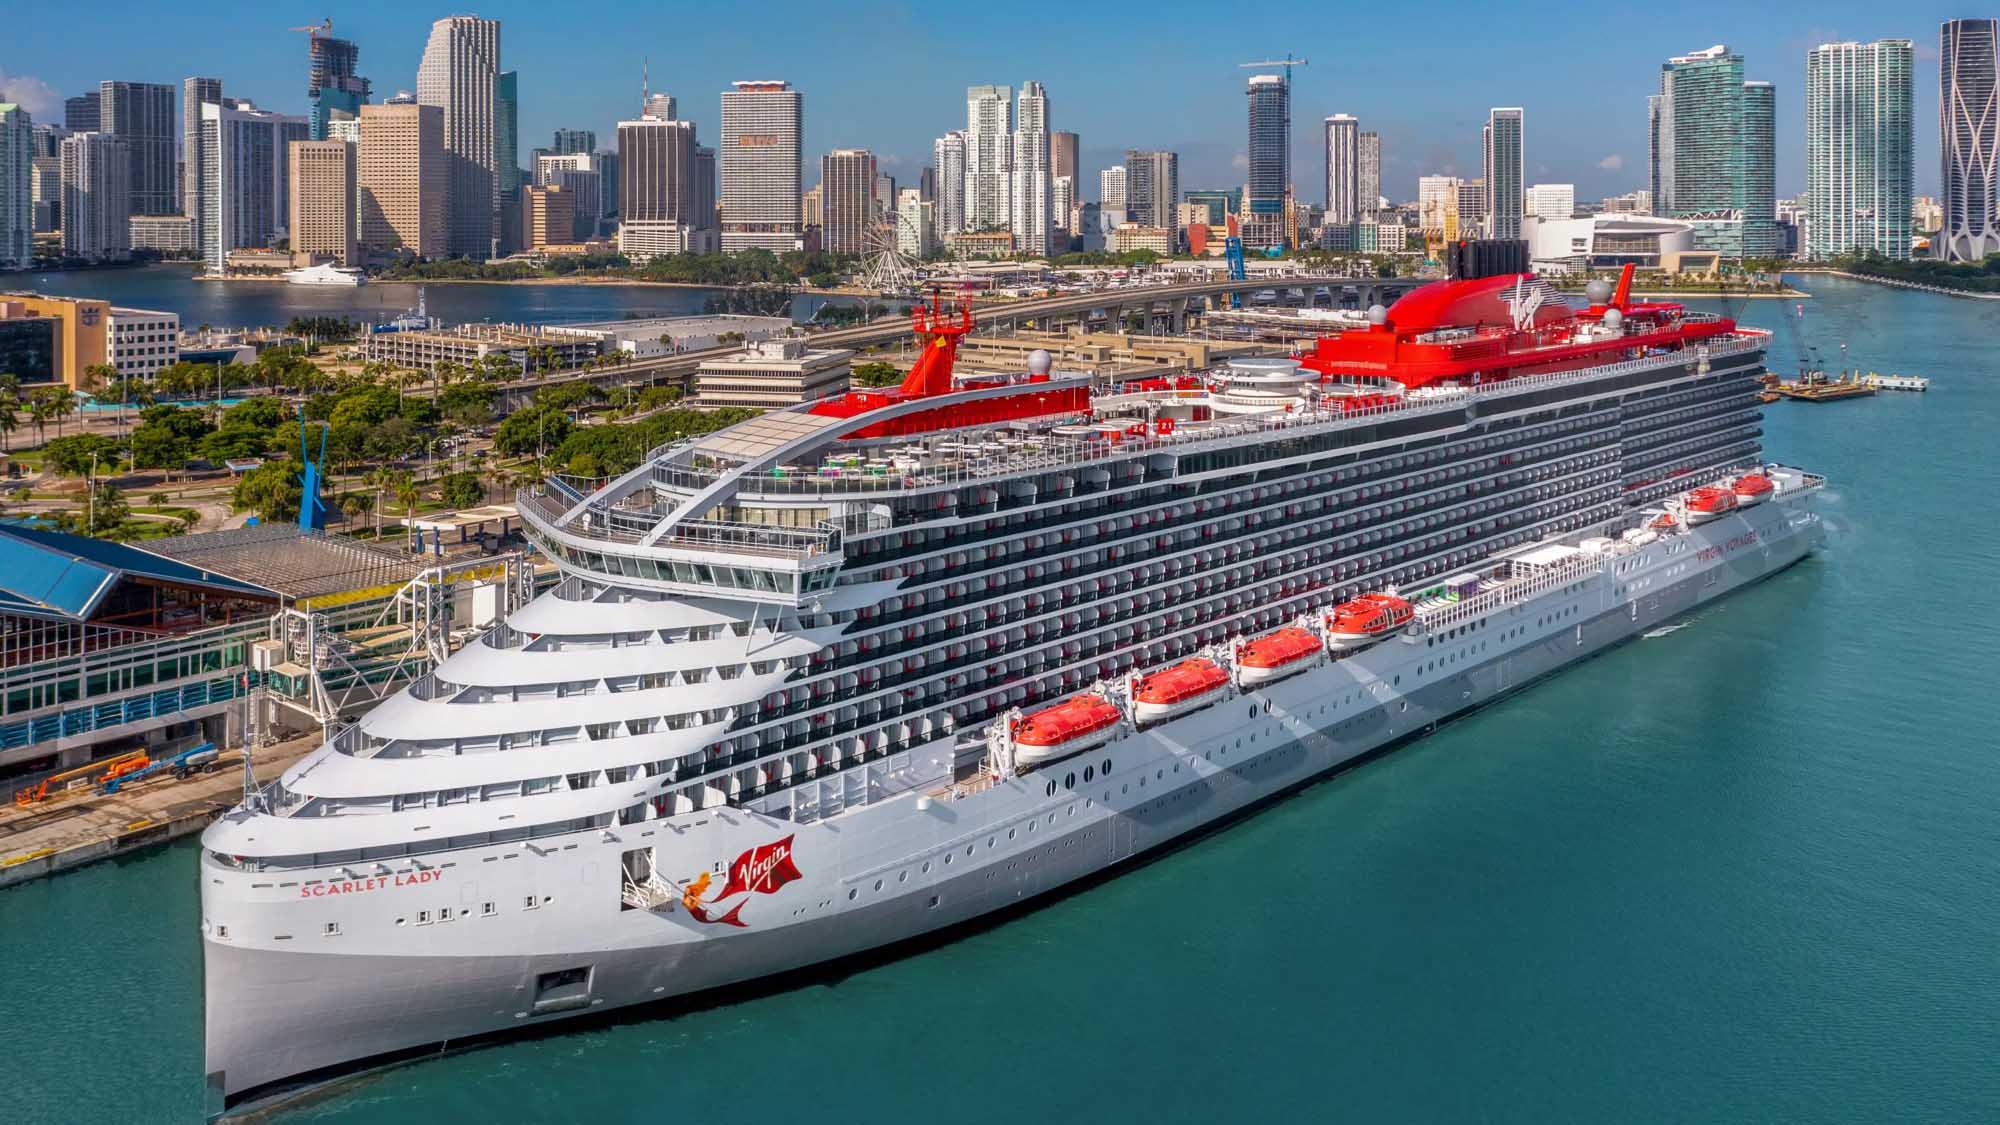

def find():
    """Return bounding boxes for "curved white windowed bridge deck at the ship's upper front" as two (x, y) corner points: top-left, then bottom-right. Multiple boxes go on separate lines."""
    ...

(516, 484), (844, 605)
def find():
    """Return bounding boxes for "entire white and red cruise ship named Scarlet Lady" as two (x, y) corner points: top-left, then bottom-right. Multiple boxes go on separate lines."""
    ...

(200, 266), (1822, 1113)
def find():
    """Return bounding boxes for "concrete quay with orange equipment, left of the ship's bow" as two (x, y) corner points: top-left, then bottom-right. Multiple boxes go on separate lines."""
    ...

(0, 733), (320, 889)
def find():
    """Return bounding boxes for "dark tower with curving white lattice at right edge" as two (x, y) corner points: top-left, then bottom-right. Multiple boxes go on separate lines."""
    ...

(1938, 20), (2000, 262)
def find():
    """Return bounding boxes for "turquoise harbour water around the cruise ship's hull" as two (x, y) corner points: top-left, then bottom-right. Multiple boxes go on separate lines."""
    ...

(0, 280), (2000, 1123)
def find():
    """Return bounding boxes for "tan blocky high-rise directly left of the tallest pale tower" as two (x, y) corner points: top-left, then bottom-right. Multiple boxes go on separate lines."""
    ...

(354, 102), (450, 258)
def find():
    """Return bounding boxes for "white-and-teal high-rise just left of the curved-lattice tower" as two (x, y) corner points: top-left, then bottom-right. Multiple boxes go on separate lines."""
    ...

(1804, 40), (1916, 260)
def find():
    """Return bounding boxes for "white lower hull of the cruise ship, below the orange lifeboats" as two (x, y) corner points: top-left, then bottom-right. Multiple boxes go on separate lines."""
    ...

(202, 492), (1822, 1105)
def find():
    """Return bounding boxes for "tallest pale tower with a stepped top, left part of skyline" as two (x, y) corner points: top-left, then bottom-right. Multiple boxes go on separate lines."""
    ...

(416, 16), (500, 258)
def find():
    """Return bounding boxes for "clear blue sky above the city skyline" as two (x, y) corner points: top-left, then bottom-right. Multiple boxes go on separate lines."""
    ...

(0, 0), (1968, 202)
